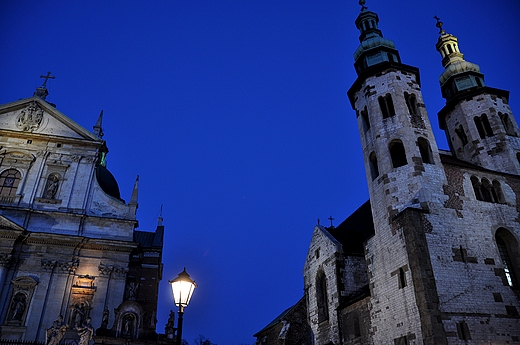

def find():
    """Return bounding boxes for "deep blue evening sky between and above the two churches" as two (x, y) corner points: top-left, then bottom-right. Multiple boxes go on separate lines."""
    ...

(0, 0), (520, 345)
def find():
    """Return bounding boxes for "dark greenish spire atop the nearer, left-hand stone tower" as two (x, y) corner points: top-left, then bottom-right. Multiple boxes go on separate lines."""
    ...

(354, 0), (401, 75)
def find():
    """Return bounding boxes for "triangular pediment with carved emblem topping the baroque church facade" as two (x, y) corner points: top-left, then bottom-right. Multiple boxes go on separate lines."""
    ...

(0, 96), (103, 142)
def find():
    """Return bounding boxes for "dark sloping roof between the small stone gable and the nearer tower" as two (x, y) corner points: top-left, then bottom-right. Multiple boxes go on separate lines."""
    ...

(327, 200), (374, 254)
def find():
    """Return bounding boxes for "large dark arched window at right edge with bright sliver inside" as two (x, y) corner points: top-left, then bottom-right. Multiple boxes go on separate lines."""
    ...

(495, 228), (520, 288)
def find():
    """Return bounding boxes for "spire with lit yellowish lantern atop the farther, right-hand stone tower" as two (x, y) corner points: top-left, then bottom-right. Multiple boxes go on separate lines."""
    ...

(433, 16), (484, 100)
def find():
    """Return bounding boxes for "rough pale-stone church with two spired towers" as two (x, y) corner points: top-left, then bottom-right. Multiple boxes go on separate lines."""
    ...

(304, 1), (520, 345)
